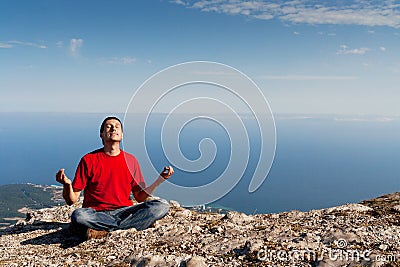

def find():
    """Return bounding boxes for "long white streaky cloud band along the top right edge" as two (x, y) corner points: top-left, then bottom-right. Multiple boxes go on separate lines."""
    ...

(177, 0), (400, 28)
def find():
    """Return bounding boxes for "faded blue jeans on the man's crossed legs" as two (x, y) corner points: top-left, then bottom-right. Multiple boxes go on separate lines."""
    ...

(71, 199), (169, 231)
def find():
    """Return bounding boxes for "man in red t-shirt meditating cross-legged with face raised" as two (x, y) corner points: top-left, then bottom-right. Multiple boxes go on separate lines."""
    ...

(56, 117), (174, 239)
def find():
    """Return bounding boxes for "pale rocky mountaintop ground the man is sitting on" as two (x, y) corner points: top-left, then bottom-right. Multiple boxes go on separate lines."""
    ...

(0, 193), (400, 267)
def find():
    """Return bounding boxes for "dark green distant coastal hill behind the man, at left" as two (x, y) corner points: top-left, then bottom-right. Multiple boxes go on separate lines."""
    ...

(0, 184), (62, 226)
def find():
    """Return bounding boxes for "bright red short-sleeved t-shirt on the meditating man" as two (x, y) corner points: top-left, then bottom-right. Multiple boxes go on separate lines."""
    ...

(72, 148), (145, 211)
